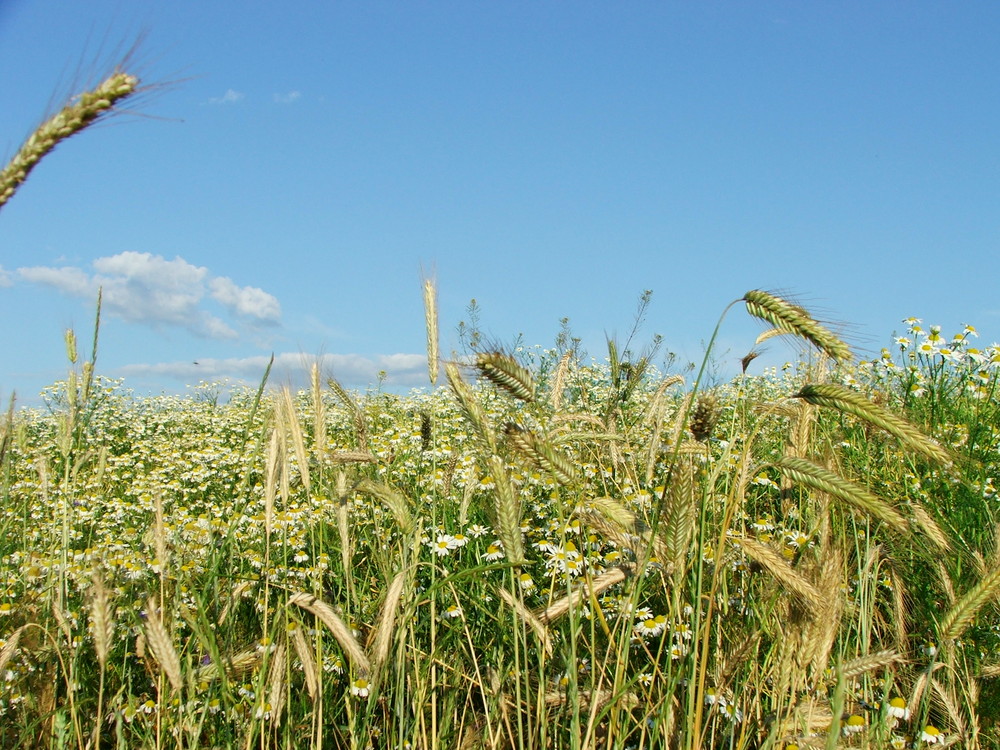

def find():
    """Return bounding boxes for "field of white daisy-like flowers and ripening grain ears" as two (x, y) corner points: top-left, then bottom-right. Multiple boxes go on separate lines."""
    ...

(0, 300), (1000, 750)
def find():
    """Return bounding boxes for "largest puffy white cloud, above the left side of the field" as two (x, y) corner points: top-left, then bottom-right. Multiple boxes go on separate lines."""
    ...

(17, 251), (281, 339)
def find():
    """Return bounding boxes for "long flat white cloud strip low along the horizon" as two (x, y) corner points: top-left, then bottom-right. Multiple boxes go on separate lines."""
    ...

(117, 352), (428, 388)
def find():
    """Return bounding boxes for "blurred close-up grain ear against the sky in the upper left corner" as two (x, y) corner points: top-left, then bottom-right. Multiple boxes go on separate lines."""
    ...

(0, 71), (139, 206)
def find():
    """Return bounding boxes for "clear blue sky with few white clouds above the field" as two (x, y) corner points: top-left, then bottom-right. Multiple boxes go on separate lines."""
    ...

(0, 0), (1000, 403)
